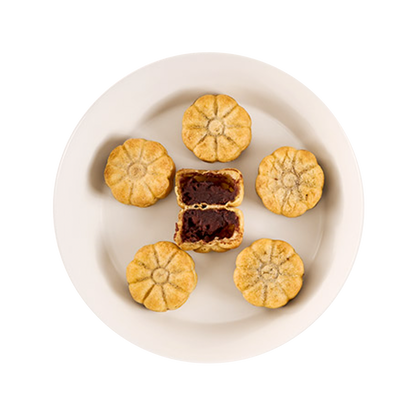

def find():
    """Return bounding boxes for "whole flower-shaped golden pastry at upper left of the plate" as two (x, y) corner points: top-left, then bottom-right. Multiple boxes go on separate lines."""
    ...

(104, 139), (175, 207)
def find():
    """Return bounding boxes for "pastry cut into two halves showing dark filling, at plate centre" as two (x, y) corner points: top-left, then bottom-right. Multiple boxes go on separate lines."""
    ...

(174, 169), (244, 253)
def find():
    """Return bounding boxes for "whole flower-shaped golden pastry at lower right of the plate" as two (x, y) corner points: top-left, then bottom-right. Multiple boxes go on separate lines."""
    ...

(234, 238), (304, 309)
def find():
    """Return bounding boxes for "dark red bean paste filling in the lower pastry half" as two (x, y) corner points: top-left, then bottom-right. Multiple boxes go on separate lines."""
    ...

(181, 209), (239, 243)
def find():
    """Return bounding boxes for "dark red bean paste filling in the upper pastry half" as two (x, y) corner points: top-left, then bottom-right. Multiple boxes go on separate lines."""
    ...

(180, 173), (238, 205)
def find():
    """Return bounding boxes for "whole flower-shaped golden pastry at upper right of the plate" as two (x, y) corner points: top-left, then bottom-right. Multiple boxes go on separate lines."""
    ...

(256, 147), (324, 217)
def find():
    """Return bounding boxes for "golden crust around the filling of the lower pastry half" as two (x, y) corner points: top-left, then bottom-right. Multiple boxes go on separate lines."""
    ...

(173, 205), (244, 253)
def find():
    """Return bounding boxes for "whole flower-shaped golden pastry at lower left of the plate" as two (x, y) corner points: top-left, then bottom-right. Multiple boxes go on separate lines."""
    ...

(127, 241), (197, 312)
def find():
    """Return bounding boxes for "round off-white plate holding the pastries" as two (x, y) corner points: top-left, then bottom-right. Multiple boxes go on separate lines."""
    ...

(51, 50), (366, 365)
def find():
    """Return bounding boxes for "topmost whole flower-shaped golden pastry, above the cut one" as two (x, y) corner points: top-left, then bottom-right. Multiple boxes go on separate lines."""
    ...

(182, 94), (251, 162)
